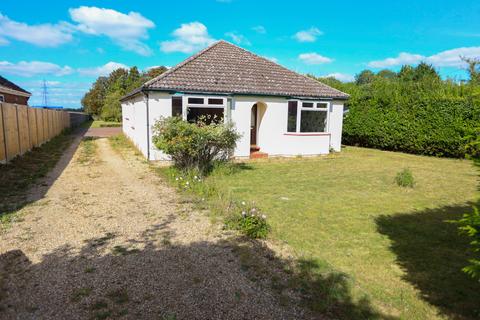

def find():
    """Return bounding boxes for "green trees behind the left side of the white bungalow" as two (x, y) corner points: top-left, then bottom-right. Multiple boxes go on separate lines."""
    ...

(82, 66), (167, 121)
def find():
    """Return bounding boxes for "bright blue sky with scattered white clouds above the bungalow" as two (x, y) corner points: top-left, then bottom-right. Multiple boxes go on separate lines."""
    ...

(0, 0), (480, 107)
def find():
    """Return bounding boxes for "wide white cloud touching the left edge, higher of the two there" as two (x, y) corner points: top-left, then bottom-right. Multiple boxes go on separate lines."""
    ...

(0, 13), (73, 47)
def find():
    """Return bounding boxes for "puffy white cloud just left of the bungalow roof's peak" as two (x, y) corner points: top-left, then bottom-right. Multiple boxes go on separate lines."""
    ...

(160, 21), (215, 53)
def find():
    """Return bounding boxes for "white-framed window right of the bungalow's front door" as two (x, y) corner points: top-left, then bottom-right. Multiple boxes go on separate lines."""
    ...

(287, 100), (329, 133)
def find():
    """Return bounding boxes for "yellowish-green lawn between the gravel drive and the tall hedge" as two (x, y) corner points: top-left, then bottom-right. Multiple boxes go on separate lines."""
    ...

(200, 147), (480, 319)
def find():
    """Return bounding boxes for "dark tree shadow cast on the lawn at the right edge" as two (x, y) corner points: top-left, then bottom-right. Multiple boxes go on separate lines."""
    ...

(376, 203), (480, 319)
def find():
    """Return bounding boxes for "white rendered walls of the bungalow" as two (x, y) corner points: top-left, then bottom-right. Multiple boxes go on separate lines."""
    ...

(122, 92), (343, 160)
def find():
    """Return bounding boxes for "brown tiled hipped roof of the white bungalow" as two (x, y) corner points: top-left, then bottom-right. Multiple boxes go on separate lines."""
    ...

(133, 40), (348, 99)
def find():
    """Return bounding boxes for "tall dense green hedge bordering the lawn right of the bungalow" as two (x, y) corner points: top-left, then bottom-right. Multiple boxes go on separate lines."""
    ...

(343, 85), (480, 157)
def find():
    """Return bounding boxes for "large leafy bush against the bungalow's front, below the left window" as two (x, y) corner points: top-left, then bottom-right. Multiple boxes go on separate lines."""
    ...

(153, 117), (240, 174)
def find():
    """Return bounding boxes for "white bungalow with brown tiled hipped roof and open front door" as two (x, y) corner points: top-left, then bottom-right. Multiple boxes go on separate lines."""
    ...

(121, 40), (348, 160)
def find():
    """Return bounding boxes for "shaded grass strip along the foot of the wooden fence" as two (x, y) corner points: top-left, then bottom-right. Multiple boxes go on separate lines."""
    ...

(0, 133), (73, 220)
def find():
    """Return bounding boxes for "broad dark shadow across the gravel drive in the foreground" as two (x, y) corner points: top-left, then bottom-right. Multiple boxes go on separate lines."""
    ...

(0, 222), (396, 319)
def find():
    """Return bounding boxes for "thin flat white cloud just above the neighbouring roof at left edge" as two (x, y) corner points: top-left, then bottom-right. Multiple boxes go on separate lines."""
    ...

(0, 61), (73, 77)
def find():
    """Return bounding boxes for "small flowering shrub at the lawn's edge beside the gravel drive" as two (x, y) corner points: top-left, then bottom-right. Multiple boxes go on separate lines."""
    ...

(225, 202), (270, 239)
